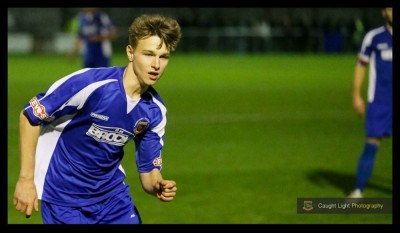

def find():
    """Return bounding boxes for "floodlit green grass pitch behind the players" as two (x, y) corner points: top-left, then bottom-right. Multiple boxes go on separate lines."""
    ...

(8, 53), (392, 224)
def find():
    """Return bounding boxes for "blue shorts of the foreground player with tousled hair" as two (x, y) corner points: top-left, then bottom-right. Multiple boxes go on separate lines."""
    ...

(42, 186), (142, 224)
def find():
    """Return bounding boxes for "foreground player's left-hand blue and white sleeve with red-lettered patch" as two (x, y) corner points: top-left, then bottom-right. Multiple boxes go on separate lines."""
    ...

(24, 69), (92, 125)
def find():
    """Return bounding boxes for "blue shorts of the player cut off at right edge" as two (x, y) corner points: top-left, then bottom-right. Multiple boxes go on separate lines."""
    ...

(365, 103), (392, 138)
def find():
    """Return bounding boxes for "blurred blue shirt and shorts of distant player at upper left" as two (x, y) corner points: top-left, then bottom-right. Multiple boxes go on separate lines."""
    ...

(78, 12), (114, 68)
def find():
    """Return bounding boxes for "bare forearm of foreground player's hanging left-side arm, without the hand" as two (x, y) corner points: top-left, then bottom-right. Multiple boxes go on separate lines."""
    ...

(19, 112), (40, 179)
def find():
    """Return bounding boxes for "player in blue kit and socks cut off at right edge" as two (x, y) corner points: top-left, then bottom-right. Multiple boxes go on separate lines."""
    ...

(349, 8), (393, 198)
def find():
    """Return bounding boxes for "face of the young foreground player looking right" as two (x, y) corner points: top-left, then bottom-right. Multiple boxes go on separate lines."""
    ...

(132, 36), (169, 86)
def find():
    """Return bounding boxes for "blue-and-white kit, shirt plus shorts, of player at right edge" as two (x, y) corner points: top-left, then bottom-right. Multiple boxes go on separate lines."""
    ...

(359, 26), (393, 138)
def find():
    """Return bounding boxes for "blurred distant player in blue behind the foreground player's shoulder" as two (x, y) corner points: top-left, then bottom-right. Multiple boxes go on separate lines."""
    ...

(70, 7), (117, 68)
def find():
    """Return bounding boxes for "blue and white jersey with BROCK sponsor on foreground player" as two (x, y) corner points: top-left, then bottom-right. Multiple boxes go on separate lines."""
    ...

(25, 67), (166, 206)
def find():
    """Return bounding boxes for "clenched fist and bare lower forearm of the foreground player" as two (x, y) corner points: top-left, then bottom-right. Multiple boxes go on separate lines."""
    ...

(139, 168), (177, 202)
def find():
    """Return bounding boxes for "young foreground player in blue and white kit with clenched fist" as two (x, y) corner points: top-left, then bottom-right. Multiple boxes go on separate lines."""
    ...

(13, 14), (181, 224)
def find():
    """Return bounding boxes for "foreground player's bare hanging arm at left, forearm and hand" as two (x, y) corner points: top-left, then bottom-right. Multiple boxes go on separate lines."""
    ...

(13, 111), (40, 216)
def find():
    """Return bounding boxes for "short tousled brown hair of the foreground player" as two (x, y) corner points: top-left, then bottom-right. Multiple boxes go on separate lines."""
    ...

(128, 14), (181, 52)
